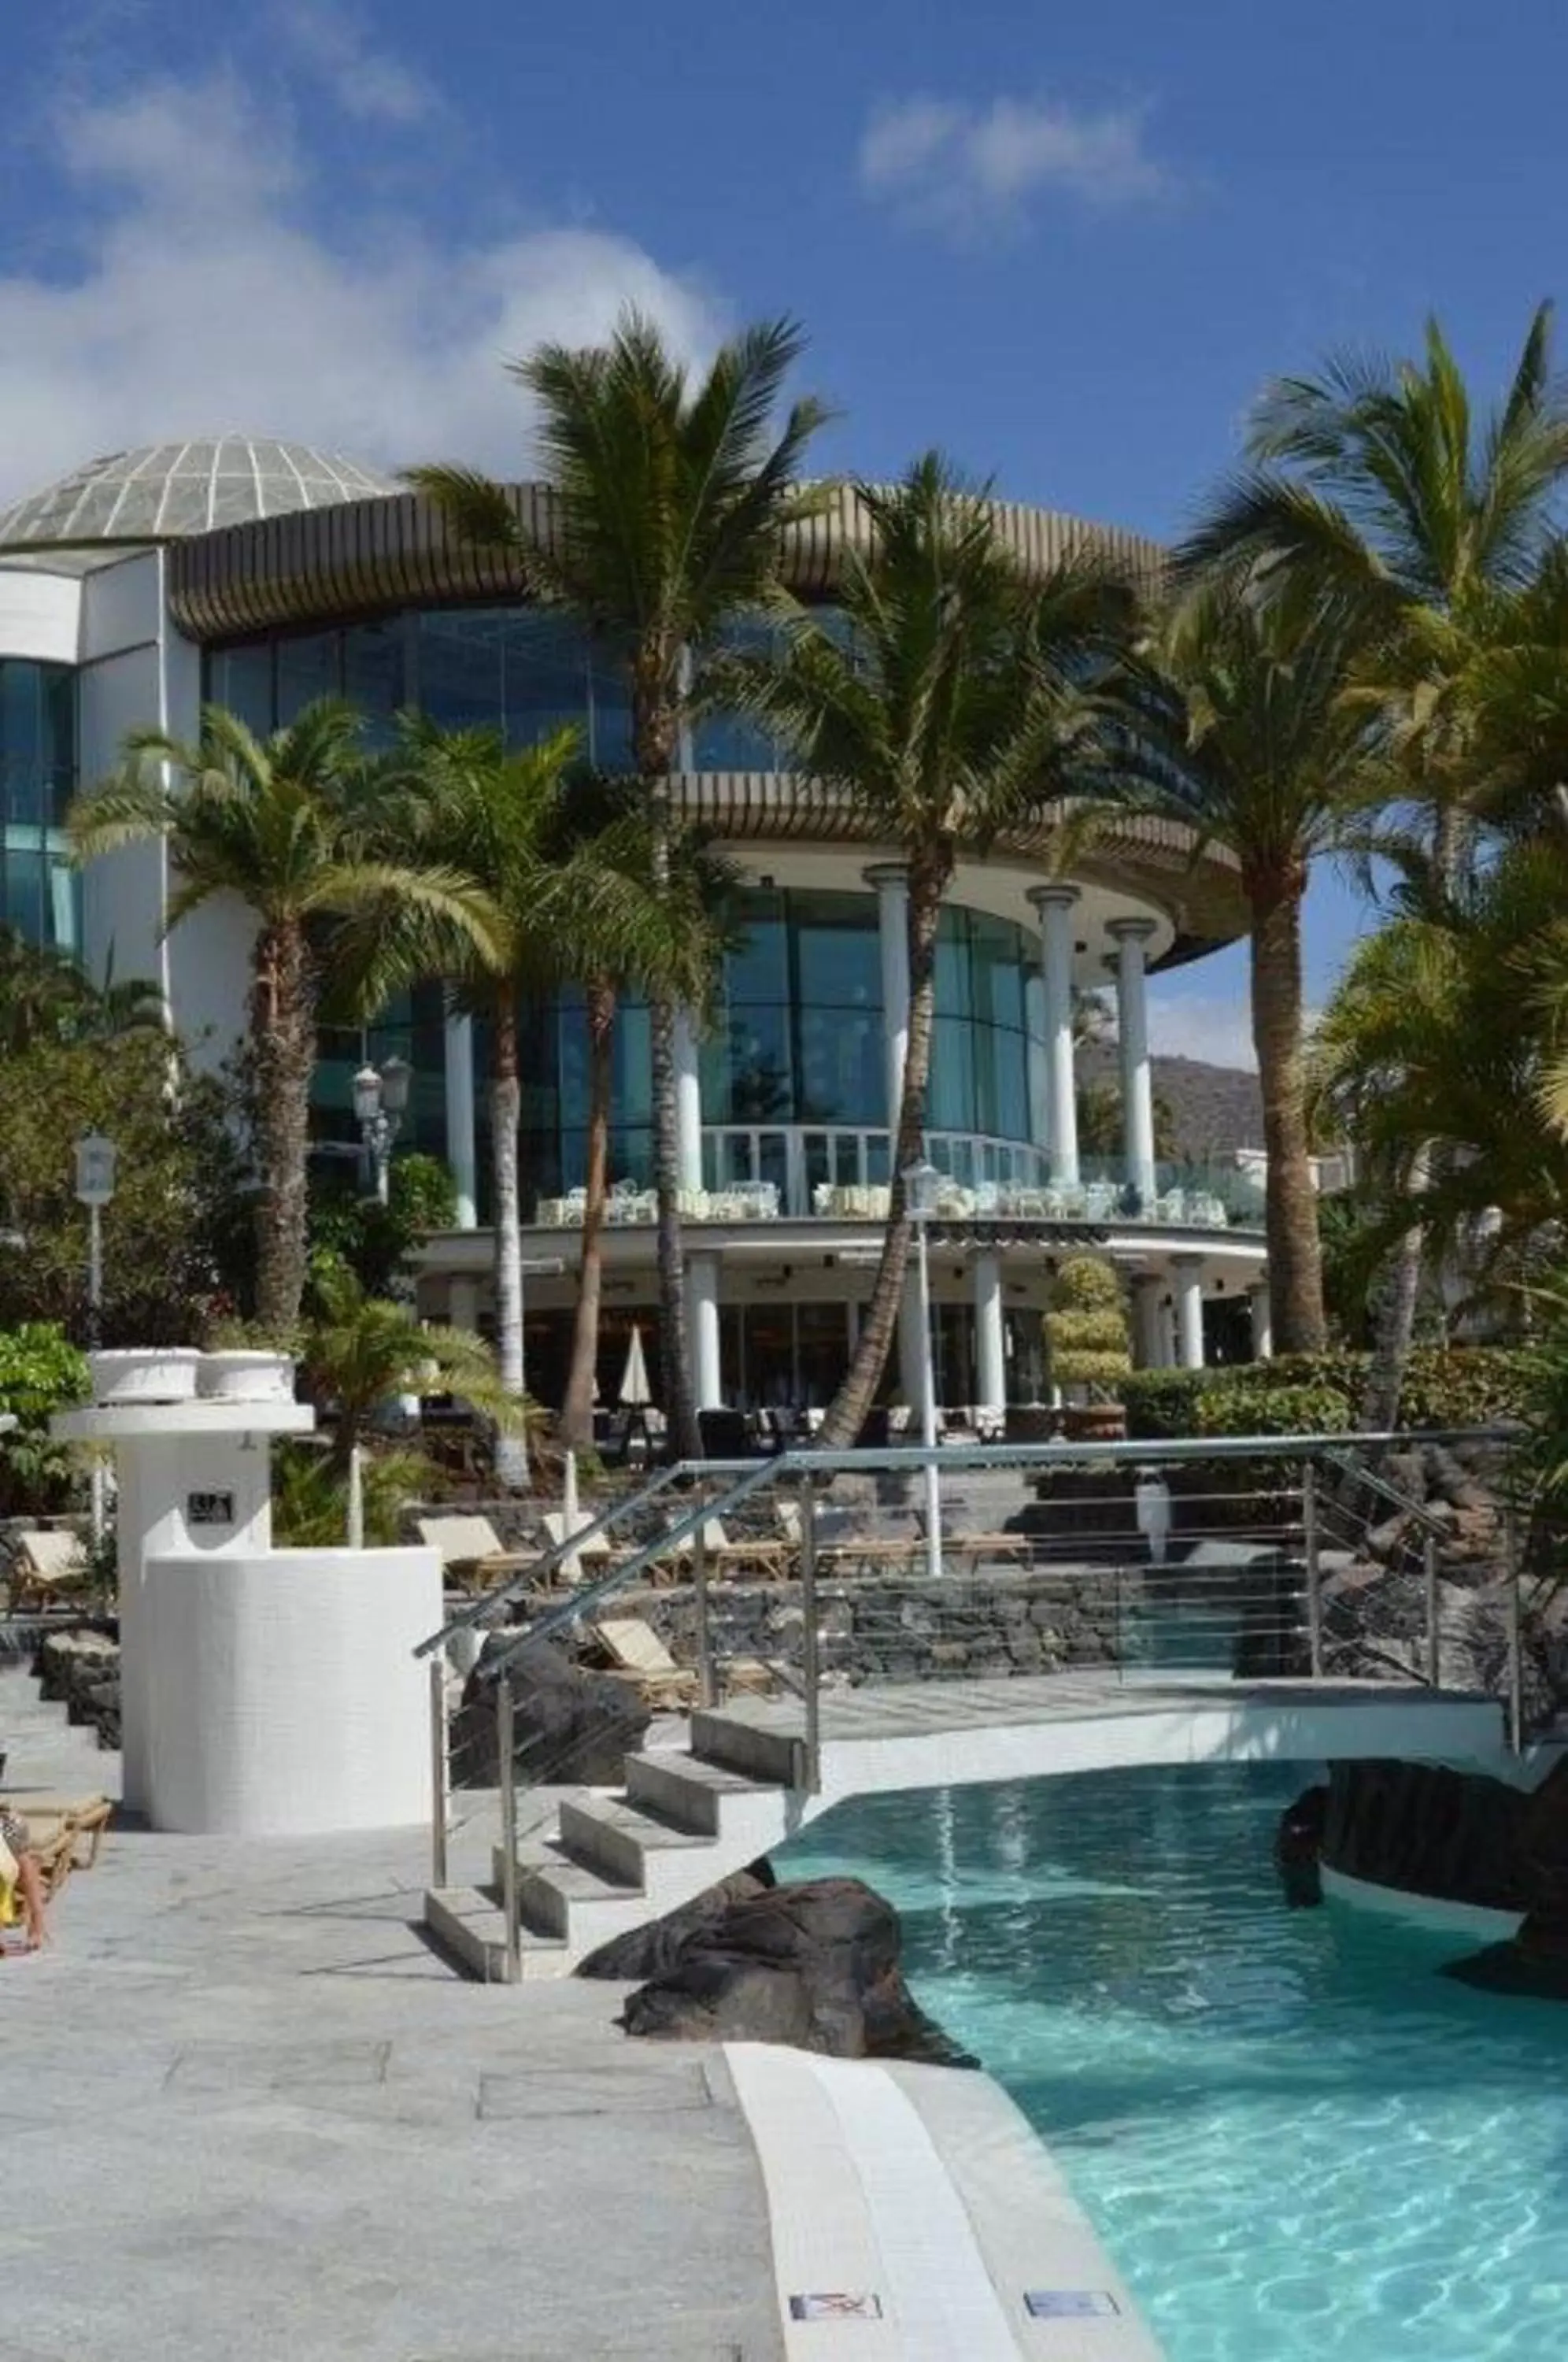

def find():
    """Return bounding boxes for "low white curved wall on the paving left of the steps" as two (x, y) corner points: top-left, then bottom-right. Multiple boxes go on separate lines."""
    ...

(142, 1549), (442, 1838)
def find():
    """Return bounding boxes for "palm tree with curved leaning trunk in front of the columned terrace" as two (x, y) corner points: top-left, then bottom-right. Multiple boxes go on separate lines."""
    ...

(711, 454), (1131, 1446)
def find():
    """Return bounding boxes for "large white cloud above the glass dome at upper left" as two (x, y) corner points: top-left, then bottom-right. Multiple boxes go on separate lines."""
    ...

(0, 73), (723, 496)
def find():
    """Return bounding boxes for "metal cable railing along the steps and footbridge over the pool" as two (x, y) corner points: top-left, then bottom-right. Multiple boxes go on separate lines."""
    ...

(418, 1431), (1523, 1942)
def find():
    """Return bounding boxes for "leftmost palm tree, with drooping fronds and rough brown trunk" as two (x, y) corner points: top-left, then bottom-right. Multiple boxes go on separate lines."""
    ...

(68, 699), (486, 1332)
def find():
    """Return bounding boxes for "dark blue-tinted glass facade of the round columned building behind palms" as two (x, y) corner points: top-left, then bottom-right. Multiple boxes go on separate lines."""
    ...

(205, 605), (1037, 1190)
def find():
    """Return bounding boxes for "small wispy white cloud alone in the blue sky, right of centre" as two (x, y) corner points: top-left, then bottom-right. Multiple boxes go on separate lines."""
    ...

(860, 97), (1176, 234)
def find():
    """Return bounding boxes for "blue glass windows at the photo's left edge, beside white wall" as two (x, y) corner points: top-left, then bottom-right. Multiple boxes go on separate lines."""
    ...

(0, 657), (80, 952)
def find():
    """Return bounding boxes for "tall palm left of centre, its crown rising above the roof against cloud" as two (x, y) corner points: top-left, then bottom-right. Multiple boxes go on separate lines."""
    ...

(409, 312), (824, 1455)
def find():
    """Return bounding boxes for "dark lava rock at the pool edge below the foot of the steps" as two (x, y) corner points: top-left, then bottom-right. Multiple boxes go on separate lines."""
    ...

(621, 1878), (975, 2067)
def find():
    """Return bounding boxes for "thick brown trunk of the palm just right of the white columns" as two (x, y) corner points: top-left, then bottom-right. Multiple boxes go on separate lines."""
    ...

(1252, 881), (1325, 1353)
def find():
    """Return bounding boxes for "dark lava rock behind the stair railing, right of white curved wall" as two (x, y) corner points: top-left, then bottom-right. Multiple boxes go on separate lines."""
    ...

(451, 1632), (654, 1788)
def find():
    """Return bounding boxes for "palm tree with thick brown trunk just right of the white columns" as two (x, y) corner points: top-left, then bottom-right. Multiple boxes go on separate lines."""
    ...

(1141, 579), (1367, 1353)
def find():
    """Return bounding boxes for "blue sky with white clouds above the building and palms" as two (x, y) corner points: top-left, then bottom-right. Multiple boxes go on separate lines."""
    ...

(0, 0), (1568, 1063)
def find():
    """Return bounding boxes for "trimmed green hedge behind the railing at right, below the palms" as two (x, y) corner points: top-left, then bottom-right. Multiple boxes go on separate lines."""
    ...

(1122, 1344), (1525, 1438)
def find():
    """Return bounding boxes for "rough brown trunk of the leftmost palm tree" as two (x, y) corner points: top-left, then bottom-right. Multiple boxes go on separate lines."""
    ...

(250, 921), (316, 1335)
